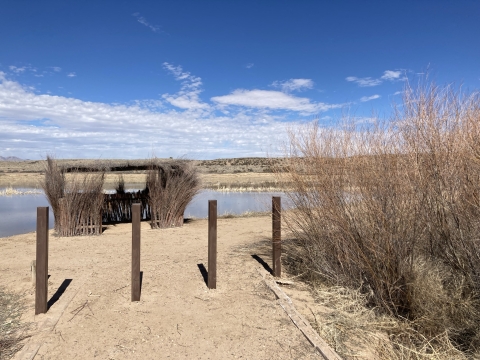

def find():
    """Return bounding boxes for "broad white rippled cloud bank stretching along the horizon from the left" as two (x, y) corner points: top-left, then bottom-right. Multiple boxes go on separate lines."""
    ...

(0, 72), (292, 159)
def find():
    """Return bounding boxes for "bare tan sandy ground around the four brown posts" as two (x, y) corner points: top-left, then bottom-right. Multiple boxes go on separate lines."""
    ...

(0, 216), (320, 359)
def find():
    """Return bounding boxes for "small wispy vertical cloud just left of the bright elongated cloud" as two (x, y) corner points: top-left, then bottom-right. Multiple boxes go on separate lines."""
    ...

(162, 62), (210, 110)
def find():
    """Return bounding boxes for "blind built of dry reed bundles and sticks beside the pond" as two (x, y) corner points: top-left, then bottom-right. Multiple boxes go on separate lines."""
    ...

(41, 157), (200, 232)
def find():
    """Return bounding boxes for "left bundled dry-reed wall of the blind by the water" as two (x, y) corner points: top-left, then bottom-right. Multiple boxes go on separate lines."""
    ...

(42, 157), (105, 236)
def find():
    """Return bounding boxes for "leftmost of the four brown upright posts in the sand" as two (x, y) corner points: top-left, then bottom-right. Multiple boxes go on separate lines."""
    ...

(35, 206), (48, 315)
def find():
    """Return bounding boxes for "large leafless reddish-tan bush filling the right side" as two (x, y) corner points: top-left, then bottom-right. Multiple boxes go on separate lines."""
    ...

(279, 84), (480, 358)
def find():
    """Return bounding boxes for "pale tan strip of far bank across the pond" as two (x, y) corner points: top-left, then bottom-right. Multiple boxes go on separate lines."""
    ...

(0, 172), (276, 189)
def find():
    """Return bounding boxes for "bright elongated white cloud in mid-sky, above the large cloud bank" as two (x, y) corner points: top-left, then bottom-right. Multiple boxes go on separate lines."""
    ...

(211, 89), (342, 113)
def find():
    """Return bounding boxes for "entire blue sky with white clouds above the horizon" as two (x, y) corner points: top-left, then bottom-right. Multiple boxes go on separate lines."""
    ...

(0, 0), (480, 159)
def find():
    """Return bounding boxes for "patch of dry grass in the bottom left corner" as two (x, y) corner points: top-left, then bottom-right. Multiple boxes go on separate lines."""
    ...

(0, 287), (30, 360)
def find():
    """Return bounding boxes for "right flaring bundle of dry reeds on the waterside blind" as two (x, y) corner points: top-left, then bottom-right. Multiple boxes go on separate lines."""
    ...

(146, 159), (200, 229)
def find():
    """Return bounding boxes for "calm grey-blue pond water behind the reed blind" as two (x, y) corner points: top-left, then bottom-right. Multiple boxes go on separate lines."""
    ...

(0, 188), (281, 237)
